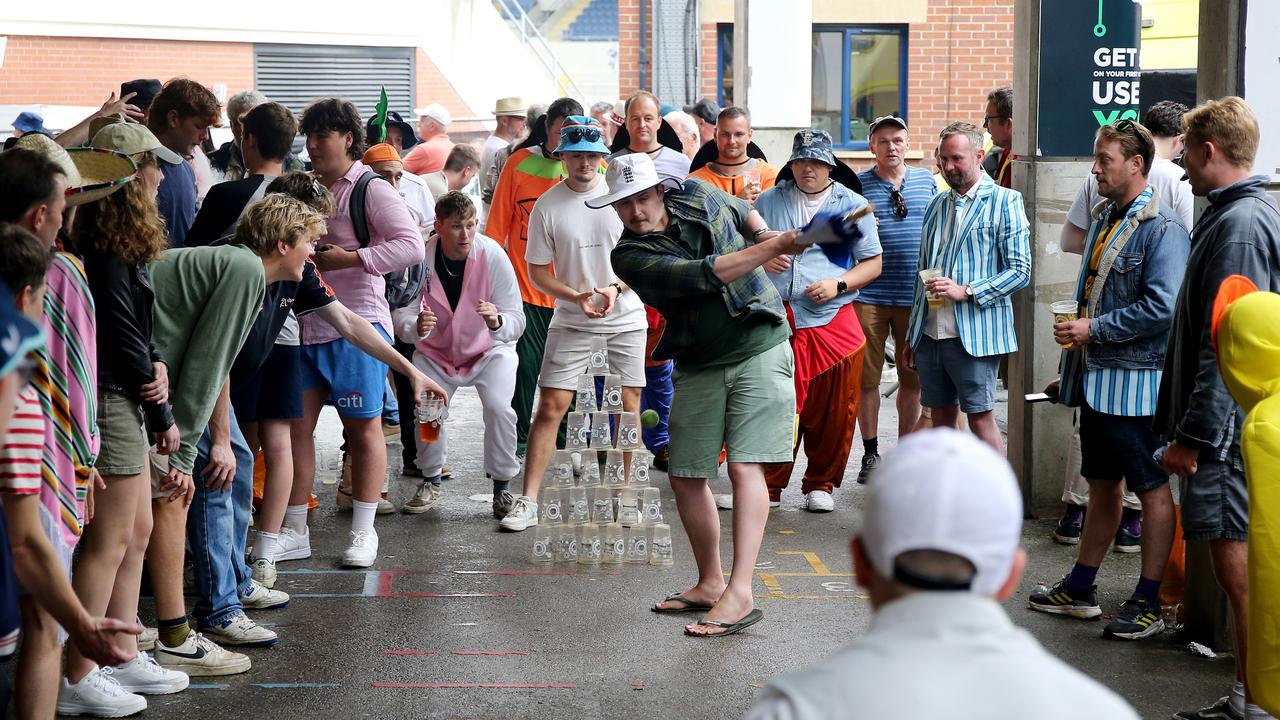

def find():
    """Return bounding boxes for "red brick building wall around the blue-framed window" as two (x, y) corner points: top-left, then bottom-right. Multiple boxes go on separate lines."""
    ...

(618, 0), (1014, 165)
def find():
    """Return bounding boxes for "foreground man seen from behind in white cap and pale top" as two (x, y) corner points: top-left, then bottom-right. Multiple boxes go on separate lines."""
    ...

(746, 429), (1138, 720)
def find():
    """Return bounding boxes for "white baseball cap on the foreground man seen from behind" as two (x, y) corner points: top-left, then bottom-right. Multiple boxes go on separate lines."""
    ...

(858, 428), (1023, 596)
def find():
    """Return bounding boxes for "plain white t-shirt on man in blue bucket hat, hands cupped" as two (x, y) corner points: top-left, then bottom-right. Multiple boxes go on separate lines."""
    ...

(525, 176), (648, 333)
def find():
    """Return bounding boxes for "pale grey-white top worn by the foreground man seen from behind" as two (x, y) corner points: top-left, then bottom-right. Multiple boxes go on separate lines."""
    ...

(746, 592), (1138, 720)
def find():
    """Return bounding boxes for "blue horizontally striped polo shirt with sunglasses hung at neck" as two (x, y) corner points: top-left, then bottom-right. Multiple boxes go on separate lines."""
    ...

(858, 165), (938, 307)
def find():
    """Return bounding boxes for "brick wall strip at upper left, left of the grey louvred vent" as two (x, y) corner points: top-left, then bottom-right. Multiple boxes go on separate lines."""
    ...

(0, 36), (253, 106)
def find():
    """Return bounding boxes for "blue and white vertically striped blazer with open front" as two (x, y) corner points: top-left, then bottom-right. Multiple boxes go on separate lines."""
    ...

(908, 173), (1032, 357)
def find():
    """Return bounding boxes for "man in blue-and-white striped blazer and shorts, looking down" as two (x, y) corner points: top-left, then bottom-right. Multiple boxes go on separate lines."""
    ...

(904, 122), (1032, 452)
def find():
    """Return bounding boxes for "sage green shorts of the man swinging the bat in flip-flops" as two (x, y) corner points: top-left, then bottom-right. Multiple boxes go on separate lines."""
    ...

(668, 342), (796, 478)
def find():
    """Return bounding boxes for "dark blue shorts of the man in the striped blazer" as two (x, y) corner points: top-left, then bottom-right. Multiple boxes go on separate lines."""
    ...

(915, 334), (1001, 415)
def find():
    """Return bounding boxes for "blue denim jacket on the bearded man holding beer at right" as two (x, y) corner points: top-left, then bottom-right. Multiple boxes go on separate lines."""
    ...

(1076, 186), (1190, 370)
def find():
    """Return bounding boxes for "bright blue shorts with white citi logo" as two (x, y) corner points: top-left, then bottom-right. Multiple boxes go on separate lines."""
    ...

(298, 324), (392, 418)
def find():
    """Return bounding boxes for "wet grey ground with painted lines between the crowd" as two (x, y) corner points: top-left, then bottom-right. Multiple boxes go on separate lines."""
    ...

(122, 391), (1233, 720)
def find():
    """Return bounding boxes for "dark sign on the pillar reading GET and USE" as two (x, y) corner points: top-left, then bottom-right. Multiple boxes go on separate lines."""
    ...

(1038, 0), (1142, 158)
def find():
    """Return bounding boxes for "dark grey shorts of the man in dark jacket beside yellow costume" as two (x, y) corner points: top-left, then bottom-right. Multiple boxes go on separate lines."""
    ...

(1181, 443), (1249, 541)
